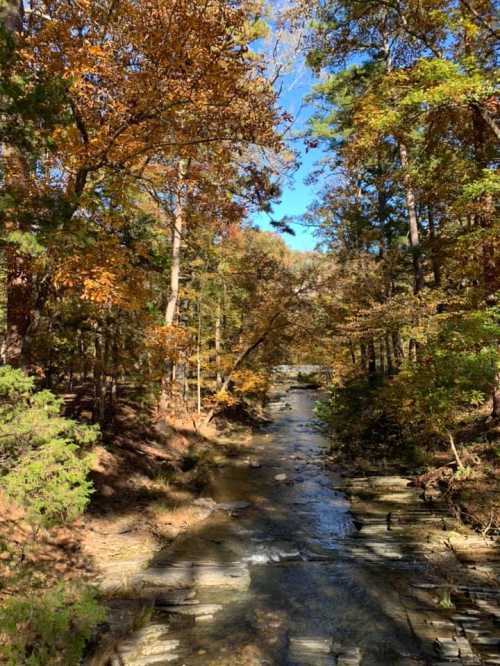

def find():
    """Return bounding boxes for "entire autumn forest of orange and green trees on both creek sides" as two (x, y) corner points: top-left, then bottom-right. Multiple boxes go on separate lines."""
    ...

(0, 0), (500, 665)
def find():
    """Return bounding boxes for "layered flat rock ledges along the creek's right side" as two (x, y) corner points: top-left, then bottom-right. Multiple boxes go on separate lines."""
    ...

(343, 475), (500, 665)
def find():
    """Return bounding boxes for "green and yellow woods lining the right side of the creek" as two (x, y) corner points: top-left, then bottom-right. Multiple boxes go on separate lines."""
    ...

(292, 1), (500, 468)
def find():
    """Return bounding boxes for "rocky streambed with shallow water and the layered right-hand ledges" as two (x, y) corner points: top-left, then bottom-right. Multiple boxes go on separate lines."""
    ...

(91, 389), (500, 666)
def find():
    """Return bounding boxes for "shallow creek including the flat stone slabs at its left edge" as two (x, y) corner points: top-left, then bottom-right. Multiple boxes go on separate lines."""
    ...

(111, 389), (498, 666)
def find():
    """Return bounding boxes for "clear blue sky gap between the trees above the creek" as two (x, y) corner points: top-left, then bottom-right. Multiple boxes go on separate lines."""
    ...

(253, 63), (320, 251)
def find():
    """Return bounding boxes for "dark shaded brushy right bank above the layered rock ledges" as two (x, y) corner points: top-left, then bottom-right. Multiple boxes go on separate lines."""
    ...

(318, 390), (500, 537)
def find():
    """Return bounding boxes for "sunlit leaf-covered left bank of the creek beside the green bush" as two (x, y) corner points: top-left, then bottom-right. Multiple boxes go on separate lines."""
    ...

(0, 405), (258, 644)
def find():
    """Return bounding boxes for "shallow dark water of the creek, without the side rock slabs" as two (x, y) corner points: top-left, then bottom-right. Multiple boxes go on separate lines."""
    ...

(146, 390), (421, 666)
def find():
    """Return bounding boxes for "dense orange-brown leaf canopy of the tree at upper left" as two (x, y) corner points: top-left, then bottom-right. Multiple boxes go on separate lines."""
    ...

(24, 0), (277, 182)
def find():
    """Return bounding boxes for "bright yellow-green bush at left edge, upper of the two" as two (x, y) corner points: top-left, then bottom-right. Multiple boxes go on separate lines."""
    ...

(0, 366), (99, 527)
